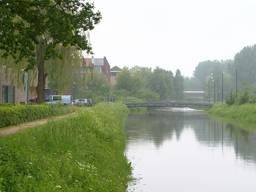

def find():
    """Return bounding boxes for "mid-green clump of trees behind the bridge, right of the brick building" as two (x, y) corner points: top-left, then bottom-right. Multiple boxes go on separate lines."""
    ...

(113, 67), (184, 100)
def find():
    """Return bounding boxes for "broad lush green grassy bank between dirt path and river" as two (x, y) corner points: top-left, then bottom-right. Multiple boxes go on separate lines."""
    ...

(0, 104), (130, 192)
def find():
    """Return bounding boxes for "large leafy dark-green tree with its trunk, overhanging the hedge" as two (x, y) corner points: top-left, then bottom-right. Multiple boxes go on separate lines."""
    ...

(0, 0), (101, 102)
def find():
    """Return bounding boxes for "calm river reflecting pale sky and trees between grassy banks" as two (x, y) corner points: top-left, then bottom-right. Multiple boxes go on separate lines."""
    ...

(125, 109), (256, 192)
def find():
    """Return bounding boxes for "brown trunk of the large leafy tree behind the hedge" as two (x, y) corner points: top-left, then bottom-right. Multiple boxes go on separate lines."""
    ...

(36, 41), (45, 103)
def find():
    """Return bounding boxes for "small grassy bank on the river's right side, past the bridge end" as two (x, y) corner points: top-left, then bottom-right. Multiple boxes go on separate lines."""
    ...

(209, 104), (256, 125)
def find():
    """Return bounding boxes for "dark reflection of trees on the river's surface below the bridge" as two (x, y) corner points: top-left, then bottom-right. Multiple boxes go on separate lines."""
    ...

(126, 112), (256, 162)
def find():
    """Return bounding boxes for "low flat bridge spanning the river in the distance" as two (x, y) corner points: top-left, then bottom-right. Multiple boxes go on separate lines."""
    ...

(124, 101), (213, 109)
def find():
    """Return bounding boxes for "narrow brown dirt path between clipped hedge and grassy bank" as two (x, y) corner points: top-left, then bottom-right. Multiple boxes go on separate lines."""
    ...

(0, 113), (76, 137)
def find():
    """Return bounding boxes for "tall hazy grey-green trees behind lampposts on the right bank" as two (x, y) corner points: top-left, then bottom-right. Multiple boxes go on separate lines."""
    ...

(188, 45), (256, 104)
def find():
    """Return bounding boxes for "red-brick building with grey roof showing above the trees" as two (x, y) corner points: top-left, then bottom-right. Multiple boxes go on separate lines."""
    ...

(81, 57), (111, 82)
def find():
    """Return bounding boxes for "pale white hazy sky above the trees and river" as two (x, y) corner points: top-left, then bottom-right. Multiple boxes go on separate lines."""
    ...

(91, 0), (256, 76)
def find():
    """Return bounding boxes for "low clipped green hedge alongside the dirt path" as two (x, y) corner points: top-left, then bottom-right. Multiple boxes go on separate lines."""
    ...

(0, 104), (75, 128)
